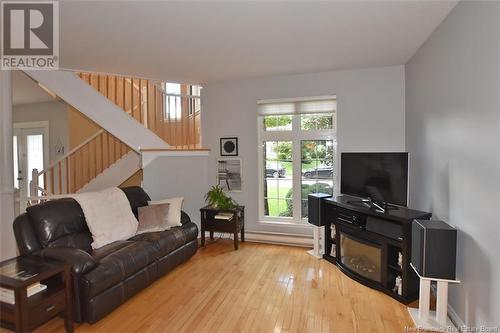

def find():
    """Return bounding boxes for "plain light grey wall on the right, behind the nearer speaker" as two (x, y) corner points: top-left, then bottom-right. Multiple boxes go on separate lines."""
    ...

(406, 1), (500, 326)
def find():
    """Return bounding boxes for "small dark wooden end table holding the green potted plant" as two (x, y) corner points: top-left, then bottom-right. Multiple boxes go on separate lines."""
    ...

(200, 206), (245, 250)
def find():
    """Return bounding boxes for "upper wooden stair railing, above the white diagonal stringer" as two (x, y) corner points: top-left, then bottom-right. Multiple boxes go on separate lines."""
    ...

(77, 73), (201, 149)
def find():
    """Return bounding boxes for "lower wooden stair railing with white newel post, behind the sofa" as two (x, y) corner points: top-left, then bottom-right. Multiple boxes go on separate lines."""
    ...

(29, 129), (130, 197)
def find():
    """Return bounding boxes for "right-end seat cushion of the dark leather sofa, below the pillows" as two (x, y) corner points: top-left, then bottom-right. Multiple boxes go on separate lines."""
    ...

(129, 222), (198, 259)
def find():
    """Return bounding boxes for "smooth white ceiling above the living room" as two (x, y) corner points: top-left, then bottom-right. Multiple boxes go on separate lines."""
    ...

(56, 1), (456, 83)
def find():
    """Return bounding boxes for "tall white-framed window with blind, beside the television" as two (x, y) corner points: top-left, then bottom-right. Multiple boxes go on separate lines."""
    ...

(258, 96), (337, 223)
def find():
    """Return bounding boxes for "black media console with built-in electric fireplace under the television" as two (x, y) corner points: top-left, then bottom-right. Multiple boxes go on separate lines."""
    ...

(313, 195), (431, 304)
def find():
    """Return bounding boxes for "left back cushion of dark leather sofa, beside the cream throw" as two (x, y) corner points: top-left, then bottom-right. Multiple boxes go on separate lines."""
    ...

(26, 198), (92, 251)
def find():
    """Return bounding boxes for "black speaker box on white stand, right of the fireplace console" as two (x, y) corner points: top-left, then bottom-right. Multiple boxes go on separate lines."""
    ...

(411, 220), (457, 280)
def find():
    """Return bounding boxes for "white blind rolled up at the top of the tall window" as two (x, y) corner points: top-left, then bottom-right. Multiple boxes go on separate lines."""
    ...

(257, 96), (337, 116)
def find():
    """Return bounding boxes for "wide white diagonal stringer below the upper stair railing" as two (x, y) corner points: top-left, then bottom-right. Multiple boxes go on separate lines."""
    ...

(24, 70), (170, 152)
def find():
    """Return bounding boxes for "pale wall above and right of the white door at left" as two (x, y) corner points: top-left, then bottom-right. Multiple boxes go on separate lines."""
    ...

(12, 101), (69, 164)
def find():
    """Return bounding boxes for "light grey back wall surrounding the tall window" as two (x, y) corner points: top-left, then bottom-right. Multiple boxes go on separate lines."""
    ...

(202, 66), (405, 234)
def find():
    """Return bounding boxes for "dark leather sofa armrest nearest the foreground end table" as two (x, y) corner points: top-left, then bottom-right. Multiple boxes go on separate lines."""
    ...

(34, 247), (97, 275)
